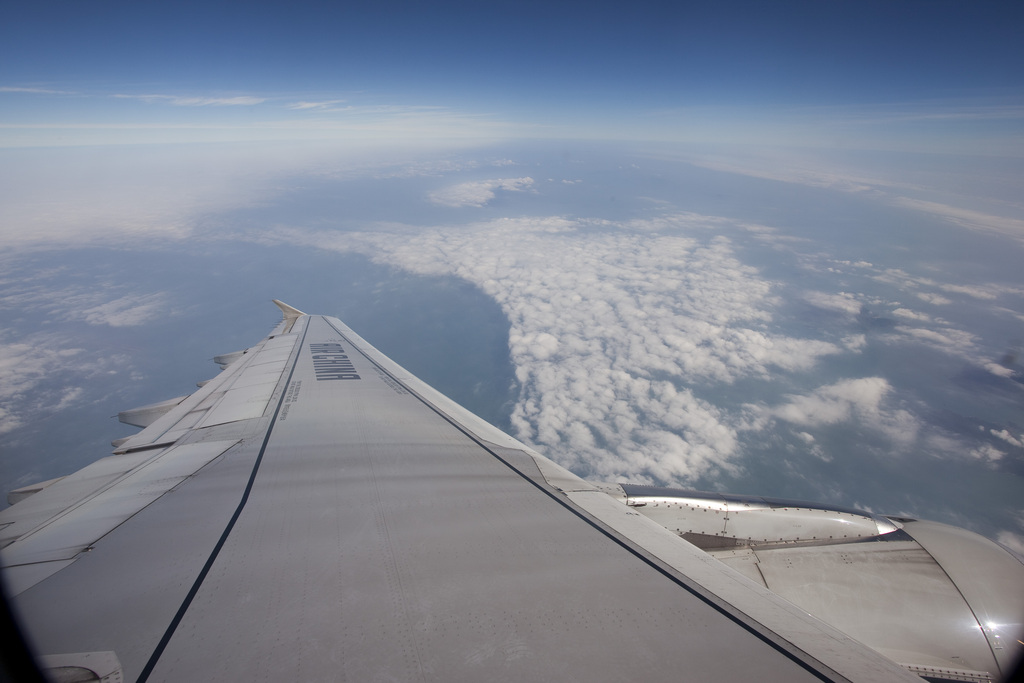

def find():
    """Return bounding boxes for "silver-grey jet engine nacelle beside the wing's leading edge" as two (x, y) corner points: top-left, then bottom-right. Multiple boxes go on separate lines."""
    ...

(601, 484), (1024, 681)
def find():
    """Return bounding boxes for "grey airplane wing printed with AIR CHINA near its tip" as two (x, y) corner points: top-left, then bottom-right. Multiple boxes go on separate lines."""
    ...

(0, 303), (970, 681)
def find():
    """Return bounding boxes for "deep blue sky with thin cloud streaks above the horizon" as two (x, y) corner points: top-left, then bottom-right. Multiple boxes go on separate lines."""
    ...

(0, 1), (1024, 149)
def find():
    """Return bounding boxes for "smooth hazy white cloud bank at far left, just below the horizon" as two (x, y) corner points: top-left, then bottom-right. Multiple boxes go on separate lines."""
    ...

(0, 144), (366, 249)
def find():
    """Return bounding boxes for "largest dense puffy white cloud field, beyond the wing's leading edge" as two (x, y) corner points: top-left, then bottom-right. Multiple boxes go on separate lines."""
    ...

(264, 214), (842, 482)
